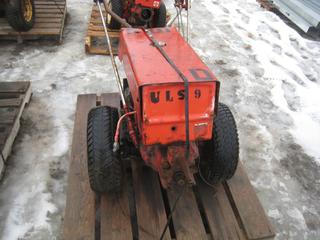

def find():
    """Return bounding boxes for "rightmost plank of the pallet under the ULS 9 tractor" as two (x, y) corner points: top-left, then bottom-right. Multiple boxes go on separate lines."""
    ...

(225, 163), (275, 239)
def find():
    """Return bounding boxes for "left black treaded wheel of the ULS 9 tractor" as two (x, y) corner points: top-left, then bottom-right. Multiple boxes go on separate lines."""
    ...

(87, 106), (122, 193)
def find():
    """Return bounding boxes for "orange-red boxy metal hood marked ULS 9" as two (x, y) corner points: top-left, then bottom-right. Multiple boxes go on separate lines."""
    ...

(119, 28), (219, 145)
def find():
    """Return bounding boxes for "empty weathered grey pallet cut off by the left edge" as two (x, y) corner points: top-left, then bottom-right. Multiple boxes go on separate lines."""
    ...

(0, 82), (31, 179)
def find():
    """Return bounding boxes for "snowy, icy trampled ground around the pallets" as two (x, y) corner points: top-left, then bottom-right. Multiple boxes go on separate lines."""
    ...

(0, 0), (320, 240)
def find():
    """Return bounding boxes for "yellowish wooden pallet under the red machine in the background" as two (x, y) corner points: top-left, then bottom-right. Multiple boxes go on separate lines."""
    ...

(85, 6), (119, 55)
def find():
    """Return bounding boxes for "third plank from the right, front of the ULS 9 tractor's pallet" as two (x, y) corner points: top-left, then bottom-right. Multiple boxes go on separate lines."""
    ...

(167, 188), (208, 240)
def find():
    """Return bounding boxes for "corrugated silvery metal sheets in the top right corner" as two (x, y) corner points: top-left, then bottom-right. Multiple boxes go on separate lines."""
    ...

(273, 0), (320, 32)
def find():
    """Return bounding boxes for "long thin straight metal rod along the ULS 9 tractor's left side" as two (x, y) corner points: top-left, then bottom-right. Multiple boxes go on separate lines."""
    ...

(97, 2), (126, 106)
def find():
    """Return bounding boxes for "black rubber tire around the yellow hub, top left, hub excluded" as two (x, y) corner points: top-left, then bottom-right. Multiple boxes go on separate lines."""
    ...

(6, 0), (35, 32)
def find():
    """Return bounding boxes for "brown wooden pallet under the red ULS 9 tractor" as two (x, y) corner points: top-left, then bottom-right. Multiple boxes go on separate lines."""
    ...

(63, 93), (275, 240)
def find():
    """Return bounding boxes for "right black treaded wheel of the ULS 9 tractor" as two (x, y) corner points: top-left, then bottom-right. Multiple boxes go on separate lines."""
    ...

(199, 103), (239, 184)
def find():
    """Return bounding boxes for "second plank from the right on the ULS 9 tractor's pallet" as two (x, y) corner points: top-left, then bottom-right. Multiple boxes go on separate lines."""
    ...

(197, 179), (246, 240)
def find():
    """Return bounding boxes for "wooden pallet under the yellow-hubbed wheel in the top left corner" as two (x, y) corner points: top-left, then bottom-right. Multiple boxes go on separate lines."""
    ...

(0, 0), (67, 43)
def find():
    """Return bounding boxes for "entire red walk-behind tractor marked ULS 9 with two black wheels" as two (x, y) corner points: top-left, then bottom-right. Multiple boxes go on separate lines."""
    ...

(87, 1), (239, 193)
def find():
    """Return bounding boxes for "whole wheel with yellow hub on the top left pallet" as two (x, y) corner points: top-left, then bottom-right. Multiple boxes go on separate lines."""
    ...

(6, 0), (35, 31)
